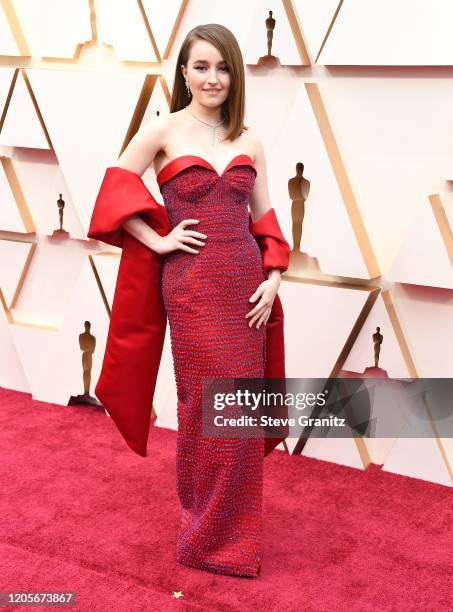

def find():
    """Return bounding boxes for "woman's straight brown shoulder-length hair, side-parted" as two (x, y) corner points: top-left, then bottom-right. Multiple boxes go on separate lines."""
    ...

(170, 23), (248, 140)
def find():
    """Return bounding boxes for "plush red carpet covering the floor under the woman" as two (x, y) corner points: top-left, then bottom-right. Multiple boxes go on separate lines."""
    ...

(0, 388), (453, 612)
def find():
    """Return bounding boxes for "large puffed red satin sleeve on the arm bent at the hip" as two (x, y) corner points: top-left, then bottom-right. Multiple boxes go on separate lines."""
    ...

(87, 166), (171, 248)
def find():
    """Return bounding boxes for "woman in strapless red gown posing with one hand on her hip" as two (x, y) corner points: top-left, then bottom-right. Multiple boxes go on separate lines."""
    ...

(88, 24), (290, 577)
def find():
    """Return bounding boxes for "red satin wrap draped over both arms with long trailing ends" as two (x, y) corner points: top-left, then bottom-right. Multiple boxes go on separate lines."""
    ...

(88, 167), (290, 457)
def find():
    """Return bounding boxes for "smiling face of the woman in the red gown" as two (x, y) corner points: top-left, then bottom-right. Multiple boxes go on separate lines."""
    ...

(181, 40), (231, 108)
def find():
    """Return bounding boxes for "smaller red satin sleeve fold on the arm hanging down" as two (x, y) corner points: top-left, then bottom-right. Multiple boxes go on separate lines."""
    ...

(249, 208), (291, 274)
